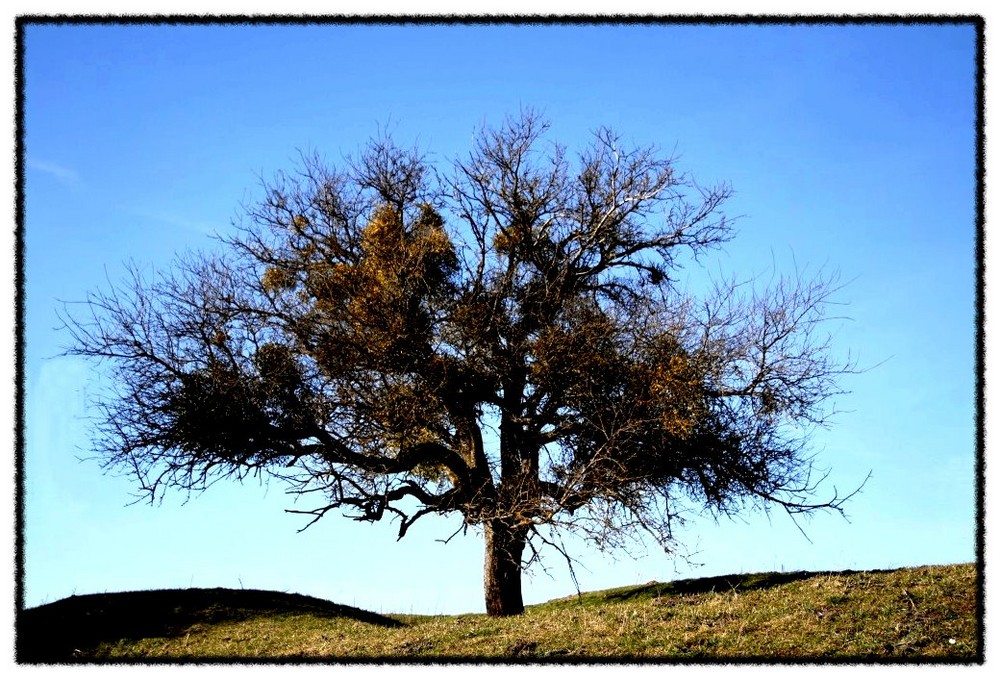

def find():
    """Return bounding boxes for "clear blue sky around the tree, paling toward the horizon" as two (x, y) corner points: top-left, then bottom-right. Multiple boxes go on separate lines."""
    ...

(22, 24), (976, 613)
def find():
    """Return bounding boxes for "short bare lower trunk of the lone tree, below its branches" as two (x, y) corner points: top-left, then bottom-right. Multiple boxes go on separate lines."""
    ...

(484, 520), (527, 616)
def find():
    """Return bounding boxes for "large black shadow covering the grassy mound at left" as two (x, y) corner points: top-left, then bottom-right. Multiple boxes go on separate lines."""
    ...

(17, 588), (403, 663)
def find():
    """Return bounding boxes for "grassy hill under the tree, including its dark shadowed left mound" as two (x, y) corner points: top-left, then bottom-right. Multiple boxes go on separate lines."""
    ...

(17, 564), (982, 663)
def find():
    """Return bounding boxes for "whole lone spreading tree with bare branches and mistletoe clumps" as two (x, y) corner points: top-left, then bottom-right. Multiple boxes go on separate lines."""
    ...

(67, 112), (852, 615)
